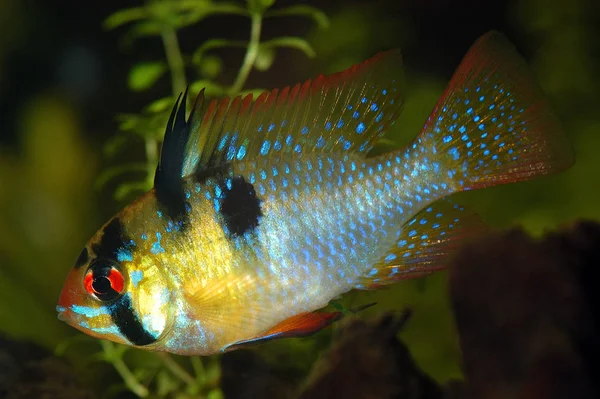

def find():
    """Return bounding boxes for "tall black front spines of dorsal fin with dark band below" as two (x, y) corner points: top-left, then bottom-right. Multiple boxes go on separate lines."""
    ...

(154, 90), (191, 227)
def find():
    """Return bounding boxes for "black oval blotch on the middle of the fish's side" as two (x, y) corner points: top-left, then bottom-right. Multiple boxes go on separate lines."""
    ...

(219, 176), (262, 236)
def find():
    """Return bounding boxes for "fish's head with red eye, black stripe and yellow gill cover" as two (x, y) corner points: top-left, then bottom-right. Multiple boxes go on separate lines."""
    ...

(57, 212), (174, 349)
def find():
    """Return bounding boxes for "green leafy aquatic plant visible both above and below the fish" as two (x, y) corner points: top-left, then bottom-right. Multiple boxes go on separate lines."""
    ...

(71, 0), (328, 398)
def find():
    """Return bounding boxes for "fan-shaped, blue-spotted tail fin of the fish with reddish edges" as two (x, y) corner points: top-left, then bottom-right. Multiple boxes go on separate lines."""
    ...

(417, 32), (573, 191)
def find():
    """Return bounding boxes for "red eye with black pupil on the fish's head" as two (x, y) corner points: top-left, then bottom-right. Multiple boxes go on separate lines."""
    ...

(83, 260), (125, 302)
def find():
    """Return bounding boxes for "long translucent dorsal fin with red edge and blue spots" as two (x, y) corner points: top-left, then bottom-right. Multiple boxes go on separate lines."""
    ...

(157, 50), (403, 178)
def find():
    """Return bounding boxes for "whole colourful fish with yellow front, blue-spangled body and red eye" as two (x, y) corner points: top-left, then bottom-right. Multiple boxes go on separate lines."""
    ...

(57, 32), (574, 356)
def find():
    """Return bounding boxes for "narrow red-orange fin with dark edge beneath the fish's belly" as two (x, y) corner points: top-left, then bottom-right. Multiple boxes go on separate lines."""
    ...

(221, 312), (342, 352)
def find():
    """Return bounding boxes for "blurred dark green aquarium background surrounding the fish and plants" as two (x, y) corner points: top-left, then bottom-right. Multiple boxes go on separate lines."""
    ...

(0, 0), (600, 397)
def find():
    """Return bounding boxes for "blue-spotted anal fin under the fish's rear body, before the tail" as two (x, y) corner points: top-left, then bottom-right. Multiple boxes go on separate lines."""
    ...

(356, 200), (486, 289)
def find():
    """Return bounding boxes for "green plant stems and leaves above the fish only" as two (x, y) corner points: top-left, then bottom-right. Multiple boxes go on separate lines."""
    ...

(97, 0), (328, 200)
